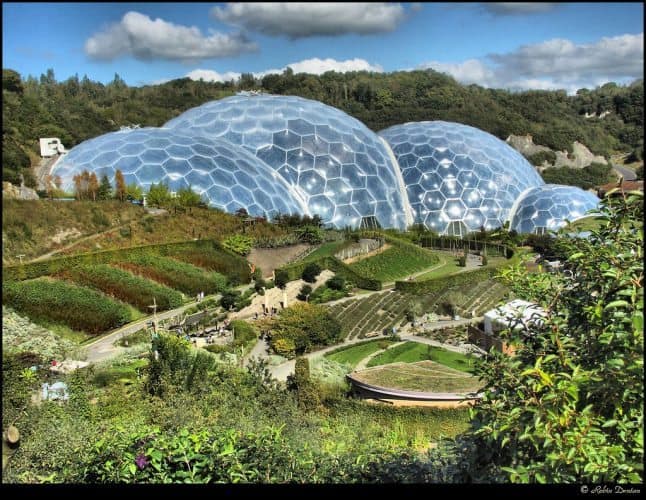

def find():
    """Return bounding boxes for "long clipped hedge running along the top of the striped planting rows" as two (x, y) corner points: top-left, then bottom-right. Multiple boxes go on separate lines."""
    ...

(2, 240), (251, 283)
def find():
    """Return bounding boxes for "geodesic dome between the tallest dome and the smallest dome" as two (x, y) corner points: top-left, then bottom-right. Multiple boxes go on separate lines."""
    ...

(379, 121), (544, 235)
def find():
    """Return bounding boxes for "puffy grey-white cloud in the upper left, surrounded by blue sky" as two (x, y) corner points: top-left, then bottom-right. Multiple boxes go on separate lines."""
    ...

(85, 11), (258, 61)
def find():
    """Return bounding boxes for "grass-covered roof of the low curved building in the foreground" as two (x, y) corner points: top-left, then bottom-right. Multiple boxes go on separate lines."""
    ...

(354, 360), (482, 394)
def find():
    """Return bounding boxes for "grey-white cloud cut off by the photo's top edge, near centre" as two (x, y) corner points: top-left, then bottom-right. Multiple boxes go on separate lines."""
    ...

(211, 2), (405, 38)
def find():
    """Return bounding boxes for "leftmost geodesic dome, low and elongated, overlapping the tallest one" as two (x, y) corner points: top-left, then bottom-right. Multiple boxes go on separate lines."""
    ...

(51, 128), (308, 217)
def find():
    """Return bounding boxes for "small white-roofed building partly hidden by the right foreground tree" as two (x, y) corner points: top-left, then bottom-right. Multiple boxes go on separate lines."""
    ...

(468, 299), (547, 354)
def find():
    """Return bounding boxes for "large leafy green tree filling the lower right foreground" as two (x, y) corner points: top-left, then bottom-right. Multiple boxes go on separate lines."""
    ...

(467, 189), (644, 483)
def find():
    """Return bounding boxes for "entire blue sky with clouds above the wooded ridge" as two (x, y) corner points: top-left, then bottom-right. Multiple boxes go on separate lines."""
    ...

(2, 2), (644, 94)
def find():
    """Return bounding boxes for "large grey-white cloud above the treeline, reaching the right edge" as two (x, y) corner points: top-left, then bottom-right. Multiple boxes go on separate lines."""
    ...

(420, 33), (644, 93)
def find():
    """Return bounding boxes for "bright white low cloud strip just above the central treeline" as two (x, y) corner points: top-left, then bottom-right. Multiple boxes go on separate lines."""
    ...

(175, 57), (383, 85)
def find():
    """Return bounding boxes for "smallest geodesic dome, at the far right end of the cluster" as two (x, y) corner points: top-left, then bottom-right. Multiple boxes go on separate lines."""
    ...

(509, 184), (600, 233)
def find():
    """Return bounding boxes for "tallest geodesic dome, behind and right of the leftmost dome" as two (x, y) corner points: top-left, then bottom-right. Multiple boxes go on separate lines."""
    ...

(164, 95), (413, 229)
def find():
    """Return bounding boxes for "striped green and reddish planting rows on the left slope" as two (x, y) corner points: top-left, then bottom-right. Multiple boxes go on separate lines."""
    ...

(2, 242), (241, 334)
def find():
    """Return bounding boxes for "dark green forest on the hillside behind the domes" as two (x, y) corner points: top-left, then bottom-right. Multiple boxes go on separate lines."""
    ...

(2, 69), (644, 187)
